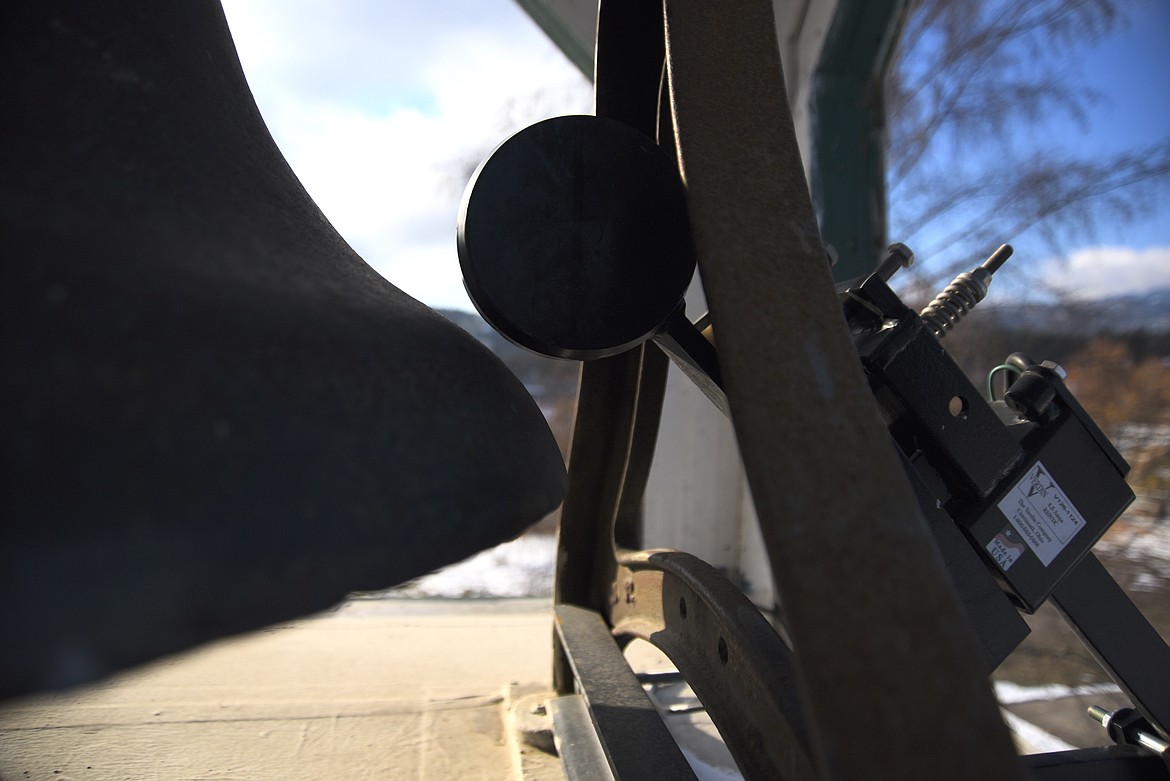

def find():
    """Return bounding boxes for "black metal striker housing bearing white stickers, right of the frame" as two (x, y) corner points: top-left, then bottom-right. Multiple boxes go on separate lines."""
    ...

(841, 274), (1134, 613)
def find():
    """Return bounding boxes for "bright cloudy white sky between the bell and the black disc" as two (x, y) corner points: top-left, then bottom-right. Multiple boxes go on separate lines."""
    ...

(217, 0), (589, 309)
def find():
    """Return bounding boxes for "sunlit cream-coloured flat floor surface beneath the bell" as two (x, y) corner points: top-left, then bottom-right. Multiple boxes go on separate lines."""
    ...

(0, 600), (561, 781)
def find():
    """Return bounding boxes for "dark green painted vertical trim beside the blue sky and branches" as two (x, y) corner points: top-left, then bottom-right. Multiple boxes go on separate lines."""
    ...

(812, 0), (907, 281)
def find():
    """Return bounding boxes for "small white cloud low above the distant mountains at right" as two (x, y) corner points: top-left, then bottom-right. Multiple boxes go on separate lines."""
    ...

(1047, 246), (1170, 299)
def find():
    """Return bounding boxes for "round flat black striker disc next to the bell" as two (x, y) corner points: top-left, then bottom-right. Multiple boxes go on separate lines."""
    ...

(459, 116), (695, 360)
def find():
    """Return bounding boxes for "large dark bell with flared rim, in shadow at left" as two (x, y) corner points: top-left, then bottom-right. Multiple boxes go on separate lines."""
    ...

(0, 0), (565, 696)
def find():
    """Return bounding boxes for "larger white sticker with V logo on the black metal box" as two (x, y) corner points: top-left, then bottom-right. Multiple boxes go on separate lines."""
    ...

(999, 461), (1085, 567)
